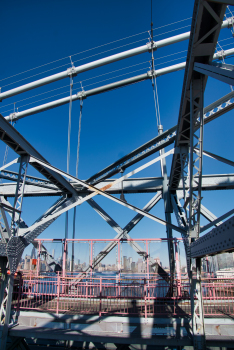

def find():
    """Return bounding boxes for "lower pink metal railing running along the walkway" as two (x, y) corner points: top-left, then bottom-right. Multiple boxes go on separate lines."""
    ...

(12, 275), (234, 318)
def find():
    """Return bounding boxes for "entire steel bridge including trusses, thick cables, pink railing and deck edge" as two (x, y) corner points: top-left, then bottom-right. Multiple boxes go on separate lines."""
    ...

(0, 0), (234, 349)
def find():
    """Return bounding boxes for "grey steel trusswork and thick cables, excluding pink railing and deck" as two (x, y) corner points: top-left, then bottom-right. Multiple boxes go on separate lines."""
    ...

(0, 0), (234, 349)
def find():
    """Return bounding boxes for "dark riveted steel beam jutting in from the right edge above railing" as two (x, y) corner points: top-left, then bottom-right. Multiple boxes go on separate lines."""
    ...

(190, 216), (234, 258)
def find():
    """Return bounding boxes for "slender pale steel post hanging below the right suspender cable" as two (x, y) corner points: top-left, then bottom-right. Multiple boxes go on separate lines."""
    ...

(158, 125), (175, 280)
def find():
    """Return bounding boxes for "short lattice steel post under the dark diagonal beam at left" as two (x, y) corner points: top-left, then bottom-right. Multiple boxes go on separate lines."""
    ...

(11, 156), (29, 236)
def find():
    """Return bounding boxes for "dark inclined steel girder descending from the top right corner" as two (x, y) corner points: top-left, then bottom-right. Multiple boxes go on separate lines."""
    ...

(170, 1), (229, 190)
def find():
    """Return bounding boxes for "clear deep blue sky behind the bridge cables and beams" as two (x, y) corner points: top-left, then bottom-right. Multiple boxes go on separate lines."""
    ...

(0, 0), (233, 262)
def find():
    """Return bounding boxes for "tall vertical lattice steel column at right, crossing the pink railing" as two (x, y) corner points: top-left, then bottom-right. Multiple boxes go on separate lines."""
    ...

(189, 75), (206, 350)
